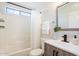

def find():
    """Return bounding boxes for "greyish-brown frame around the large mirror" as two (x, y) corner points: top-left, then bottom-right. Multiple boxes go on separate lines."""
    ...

(56, 2), (79, 31)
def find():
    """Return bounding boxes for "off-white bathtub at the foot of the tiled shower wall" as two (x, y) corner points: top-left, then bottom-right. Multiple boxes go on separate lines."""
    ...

(8, 48), (31, 56)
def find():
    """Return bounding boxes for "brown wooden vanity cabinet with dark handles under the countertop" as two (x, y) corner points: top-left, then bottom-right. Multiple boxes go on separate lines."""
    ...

(44, 43), (75, 56)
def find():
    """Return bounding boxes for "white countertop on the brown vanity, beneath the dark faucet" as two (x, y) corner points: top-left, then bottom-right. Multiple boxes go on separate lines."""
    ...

(45, 39), (79, 56)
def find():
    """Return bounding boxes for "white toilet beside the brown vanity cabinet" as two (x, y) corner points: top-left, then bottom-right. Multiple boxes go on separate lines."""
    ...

(30, 39), (45, 56)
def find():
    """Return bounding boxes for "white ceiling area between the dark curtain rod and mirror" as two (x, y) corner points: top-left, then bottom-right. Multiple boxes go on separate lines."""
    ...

(14, 2), (55, 11)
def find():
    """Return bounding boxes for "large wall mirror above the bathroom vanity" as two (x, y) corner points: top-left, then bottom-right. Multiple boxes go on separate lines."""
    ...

(56, 2), (79, 30)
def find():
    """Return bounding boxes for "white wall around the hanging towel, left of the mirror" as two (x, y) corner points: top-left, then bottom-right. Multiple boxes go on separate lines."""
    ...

(41, 4), (57, 38)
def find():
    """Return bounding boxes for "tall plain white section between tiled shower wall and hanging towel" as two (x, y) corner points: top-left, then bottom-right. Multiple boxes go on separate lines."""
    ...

(31, 10), (41, 49)
